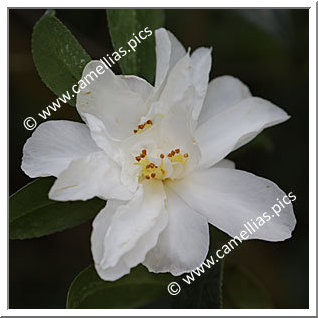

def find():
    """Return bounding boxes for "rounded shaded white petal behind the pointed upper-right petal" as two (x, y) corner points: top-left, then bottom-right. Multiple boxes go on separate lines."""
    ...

(199, 75), (251, 125)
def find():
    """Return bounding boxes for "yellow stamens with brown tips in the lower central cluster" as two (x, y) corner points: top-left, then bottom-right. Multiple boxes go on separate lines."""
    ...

(135, 149), (189, 180)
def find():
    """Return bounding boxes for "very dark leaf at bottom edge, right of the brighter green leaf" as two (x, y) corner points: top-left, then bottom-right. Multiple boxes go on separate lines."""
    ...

(172, 261), (223, 309)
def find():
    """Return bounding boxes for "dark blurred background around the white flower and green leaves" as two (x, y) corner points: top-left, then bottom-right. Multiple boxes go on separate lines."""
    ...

(9, 9), (309, 308)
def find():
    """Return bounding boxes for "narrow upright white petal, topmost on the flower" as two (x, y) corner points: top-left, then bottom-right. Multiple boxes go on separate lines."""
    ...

(155, 28), (186, 87)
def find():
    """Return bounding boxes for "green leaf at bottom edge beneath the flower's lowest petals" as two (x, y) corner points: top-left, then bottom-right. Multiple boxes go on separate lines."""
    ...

(66, 265), (172, 309)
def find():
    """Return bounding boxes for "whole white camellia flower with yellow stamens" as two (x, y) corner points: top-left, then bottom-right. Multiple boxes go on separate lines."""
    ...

(22, 29), (296, 281)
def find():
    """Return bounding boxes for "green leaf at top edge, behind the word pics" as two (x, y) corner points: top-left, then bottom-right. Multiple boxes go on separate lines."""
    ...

(107, 9), (164, 83)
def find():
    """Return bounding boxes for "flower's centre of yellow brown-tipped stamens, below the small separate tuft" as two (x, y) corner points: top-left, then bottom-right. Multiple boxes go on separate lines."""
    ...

(135, 149), (189, 181)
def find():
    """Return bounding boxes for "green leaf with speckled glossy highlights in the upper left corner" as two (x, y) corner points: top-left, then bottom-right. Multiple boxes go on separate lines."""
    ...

(32, 10), (91, 106)
